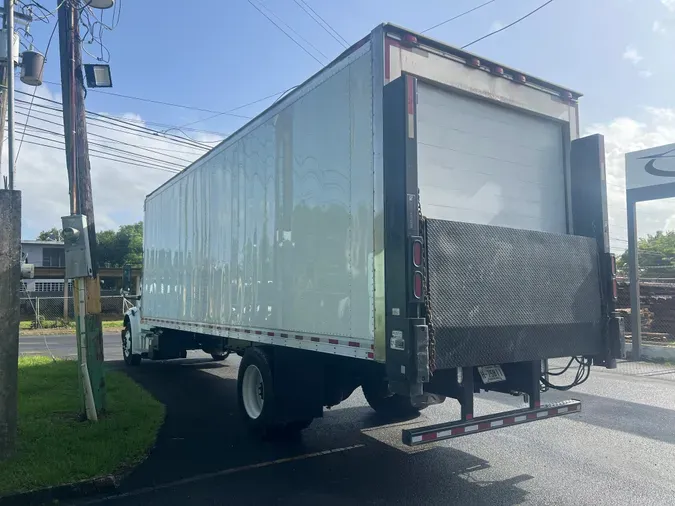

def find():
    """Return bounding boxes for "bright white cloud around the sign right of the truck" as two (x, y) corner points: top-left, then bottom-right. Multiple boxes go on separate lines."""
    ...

(585, 107), (675, 253)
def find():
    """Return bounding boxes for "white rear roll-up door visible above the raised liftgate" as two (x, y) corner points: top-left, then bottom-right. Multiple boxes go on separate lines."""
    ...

(418, 83), (567, 233)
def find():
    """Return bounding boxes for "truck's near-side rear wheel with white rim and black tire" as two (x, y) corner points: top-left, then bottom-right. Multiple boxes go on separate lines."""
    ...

(237, 347), (312, 439)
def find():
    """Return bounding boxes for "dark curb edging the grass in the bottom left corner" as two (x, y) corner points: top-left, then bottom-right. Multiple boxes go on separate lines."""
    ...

(0, 475), (119, 506)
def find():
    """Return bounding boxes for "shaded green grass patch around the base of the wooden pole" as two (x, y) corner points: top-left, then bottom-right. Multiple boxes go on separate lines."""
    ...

(0, 356), (164, 496)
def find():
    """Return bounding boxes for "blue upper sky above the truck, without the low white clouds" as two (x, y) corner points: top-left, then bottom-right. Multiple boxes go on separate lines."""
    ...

(11, 0), (675, 247)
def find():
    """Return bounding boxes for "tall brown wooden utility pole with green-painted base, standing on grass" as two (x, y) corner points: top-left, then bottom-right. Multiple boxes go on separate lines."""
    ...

(56, 0), (106, 420)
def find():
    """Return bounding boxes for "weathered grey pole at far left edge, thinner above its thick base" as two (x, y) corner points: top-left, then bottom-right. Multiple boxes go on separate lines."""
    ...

(0, 0), (21, 460)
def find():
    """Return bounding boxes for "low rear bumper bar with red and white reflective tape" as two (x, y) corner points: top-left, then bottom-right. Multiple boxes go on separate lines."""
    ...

(401, 399), (581, 446)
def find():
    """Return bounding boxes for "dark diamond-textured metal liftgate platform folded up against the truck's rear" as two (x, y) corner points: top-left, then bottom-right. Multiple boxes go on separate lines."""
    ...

(426, 219), (603, 369)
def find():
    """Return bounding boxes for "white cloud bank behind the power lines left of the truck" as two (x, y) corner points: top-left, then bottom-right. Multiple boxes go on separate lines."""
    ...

(2, 86), (222, 239)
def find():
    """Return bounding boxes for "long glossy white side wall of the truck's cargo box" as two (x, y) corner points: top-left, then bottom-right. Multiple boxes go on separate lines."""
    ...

(142, 45), (374, 342)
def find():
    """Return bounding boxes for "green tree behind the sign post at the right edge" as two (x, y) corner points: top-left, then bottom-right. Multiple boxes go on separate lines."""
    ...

(616, 231), (675, 278)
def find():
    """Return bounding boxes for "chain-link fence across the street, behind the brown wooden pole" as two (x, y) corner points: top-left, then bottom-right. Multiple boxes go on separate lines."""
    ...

(20, 295), (126, 330)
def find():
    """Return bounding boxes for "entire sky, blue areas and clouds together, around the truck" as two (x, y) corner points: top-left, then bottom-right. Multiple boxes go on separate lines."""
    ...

(7, 0), (675, 252)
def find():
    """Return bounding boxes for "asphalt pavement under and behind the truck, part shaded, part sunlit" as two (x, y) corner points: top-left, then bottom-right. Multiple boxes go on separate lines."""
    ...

(51, 354), (675, 506)
